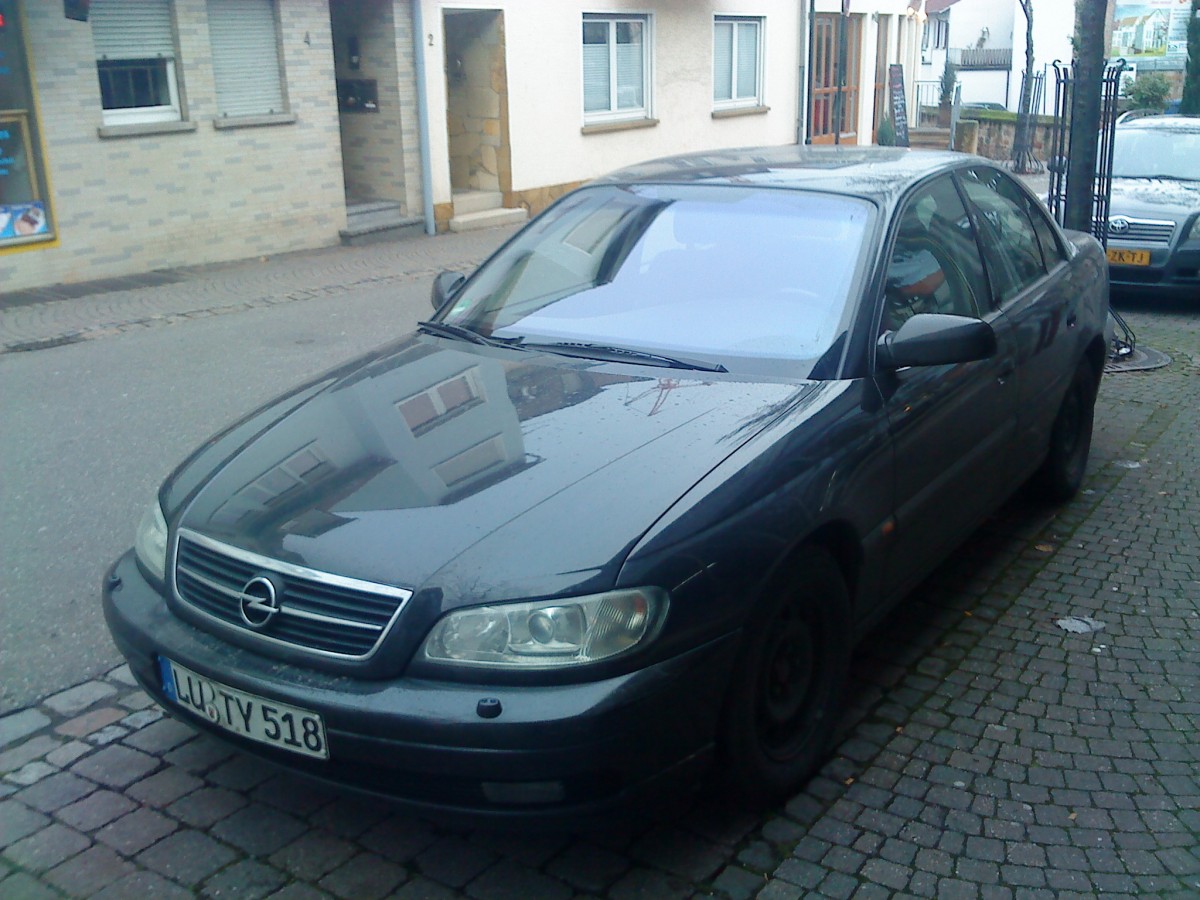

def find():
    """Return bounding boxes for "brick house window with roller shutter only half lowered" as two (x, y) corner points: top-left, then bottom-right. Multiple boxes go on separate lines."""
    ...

(90, 0), (181, 125)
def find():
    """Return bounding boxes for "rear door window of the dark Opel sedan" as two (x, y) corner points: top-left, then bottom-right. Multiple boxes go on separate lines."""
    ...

(962, 166), (1046, 304)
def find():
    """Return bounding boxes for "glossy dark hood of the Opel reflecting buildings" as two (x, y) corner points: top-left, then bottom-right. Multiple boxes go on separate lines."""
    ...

(174, 336), (811, 602)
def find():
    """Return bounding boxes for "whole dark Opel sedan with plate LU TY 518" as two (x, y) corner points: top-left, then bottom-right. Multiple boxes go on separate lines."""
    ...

(103, 148), (1108, 817)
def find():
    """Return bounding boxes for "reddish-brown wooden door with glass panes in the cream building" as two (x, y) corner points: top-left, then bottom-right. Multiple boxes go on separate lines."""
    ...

(809, 13), (863, 144)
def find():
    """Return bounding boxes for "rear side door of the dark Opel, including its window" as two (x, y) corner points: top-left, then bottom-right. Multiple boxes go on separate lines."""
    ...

(959, 166), (1082, 488)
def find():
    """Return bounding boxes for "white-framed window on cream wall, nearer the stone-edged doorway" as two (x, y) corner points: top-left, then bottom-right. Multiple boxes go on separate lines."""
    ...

(583, 13), (650, 121)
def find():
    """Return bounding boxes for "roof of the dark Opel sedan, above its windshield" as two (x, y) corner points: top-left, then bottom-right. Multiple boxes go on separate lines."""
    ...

(598, 144), (992, 205)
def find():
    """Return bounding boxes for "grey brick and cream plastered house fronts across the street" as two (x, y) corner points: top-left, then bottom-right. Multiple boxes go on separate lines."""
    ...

(0, 0), (920, 292)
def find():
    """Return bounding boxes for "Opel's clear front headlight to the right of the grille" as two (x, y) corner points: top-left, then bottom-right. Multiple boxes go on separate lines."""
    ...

(421, 588), (667, 668)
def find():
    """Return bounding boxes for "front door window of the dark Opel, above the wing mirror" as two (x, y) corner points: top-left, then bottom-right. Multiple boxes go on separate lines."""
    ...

(883, 176), (988, 329)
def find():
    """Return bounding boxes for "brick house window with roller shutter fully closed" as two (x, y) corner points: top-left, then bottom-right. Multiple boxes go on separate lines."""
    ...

(208, 0), (287, 118)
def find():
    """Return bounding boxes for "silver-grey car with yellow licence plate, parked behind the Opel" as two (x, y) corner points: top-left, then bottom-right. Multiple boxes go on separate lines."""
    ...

(1108, 115), (1200, 301)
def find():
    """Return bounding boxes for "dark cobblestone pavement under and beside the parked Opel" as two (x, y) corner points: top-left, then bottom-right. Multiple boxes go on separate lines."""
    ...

(0, 229), (1200, 900)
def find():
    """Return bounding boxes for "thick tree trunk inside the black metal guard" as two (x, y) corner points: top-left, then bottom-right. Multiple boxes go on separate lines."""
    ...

(1063, 0), (1108, 232)
